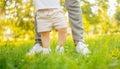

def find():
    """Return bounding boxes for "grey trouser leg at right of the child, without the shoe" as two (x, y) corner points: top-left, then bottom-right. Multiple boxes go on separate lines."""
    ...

(65, 0), (84, 44)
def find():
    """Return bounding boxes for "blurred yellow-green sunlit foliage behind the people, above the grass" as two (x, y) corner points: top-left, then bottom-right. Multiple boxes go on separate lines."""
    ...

(0, 0), (120, 41)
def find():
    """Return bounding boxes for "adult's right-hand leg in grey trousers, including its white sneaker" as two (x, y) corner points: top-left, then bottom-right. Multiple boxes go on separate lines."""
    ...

(65, 0), (90, 55)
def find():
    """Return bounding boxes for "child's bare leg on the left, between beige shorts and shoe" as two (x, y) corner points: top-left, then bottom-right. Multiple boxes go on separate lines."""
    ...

(40, 31), (50, 48)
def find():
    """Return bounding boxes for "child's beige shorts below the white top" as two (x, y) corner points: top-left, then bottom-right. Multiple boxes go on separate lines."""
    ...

(36, 9), (67, 32)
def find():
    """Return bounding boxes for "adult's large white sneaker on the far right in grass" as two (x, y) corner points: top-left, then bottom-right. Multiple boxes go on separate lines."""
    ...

(76, 42), (91, 55)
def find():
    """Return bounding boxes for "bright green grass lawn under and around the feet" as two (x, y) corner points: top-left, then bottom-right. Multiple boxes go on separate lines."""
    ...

(0, 35), (120, 69)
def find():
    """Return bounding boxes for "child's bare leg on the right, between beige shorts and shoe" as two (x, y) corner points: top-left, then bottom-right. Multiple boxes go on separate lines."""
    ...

(58, 28), (67, 46)
